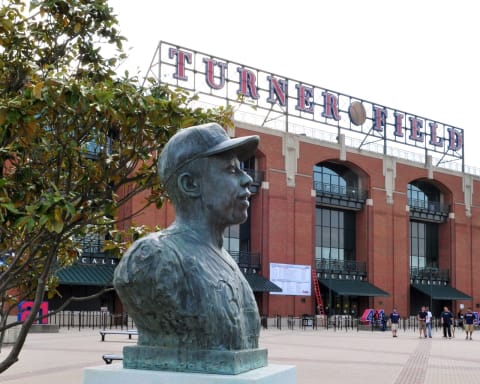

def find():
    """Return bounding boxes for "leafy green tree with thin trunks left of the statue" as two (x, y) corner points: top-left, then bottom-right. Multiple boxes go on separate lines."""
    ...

(0, 0), (232, 373)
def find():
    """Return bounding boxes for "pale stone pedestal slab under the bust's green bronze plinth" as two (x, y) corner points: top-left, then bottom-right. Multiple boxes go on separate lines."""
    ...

(83, 364), (296, 384)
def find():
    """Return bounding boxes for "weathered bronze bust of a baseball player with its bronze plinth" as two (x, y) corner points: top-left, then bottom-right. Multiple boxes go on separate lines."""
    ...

(114, 123), (267, 374)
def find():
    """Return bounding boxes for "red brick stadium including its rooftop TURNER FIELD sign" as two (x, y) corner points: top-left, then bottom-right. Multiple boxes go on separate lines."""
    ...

(52, 43), (480, 316)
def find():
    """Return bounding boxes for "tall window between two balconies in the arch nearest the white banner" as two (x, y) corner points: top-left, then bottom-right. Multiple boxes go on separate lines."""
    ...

(315, 207), (355, 261)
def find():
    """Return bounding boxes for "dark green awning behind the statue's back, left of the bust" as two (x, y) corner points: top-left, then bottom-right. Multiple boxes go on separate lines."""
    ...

(57, 264), (115, 287)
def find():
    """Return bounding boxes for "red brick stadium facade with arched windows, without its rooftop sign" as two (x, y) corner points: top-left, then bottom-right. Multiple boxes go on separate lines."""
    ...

(126, 123), (480, 316)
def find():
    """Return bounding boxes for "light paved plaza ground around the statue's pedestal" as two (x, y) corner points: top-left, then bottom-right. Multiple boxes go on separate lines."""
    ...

(0, 328), (480, 384)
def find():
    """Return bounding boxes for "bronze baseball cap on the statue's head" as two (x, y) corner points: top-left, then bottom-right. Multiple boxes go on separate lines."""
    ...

(158, 123), (260, 185)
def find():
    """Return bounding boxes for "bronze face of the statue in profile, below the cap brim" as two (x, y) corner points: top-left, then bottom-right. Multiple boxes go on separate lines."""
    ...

(201, 153), (252, 225)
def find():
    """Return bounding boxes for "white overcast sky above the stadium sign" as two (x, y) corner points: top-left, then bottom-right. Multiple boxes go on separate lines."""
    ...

(109, 0), (480, 168)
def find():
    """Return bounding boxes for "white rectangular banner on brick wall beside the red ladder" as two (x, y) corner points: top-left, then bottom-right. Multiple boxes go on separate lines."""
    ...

(270, 263), (312, 296)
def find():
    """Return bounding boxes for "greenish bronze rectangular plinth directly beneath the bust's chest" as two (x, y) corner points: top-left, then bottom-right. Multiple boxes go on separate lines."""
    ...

(123, 345), (268, 375)
